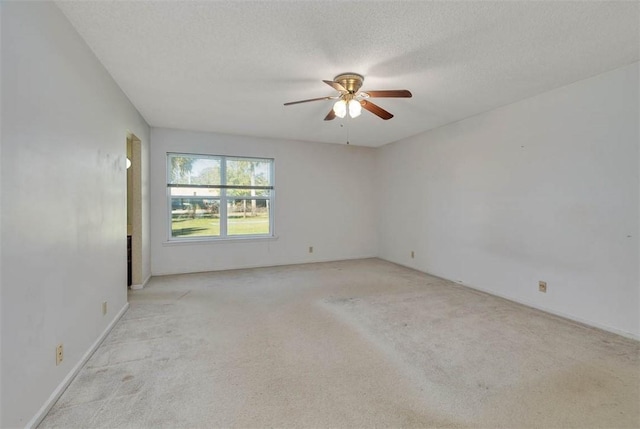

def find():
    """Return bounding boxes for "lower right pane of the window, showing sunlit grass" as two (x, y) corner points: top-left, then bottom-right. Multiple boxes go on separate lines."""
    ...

(227, 199), (270, 235)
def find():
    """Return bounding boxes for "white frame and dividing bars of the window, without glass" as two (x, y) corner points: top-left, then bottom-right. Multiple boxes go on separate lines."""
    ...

(166, 152), (275, 243)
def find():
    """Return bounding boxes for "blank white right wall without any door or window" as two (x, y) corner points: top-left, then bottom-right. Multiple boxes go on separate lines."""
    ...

(377, 63), (640, 338)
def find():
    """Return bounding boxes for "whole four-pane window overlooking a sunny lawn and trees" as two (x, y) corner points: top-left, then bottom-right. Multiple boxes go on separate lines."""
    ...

(167, 153), (274, 241)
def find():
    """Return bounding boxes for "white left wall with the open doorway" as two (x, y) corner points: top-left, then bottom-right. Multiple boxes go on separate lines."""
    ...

(0, 2), (149, 428)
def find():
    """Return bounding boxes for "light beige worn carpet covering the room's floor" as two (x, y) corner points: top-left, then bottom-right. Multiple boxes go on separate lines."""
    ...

(40, 259), (640, 428)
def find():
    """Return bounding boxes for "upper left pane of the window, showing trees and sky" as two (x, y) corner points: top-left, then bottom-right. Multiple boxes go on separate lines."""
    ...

(169, 154), (220, 185)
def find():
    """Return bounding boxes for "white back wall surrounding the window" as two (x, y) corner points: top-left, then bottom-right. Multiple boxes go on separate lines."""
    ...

(151, 128), (378, 275)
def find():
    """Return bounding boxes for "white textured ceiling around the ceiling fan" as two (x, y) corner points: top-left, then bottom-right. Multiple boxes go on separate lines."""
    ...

(57, 1), (640, 146)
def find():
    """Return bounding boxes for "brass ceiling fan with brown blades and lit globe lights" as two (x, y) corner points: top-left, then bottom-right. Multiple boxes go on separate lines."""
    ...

(284, 73), (412, 121)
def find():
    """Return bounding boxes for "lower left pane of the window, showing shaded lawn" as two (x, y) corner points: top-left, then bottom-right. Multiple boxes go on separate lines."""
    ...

(171, 197), (220, 237)
